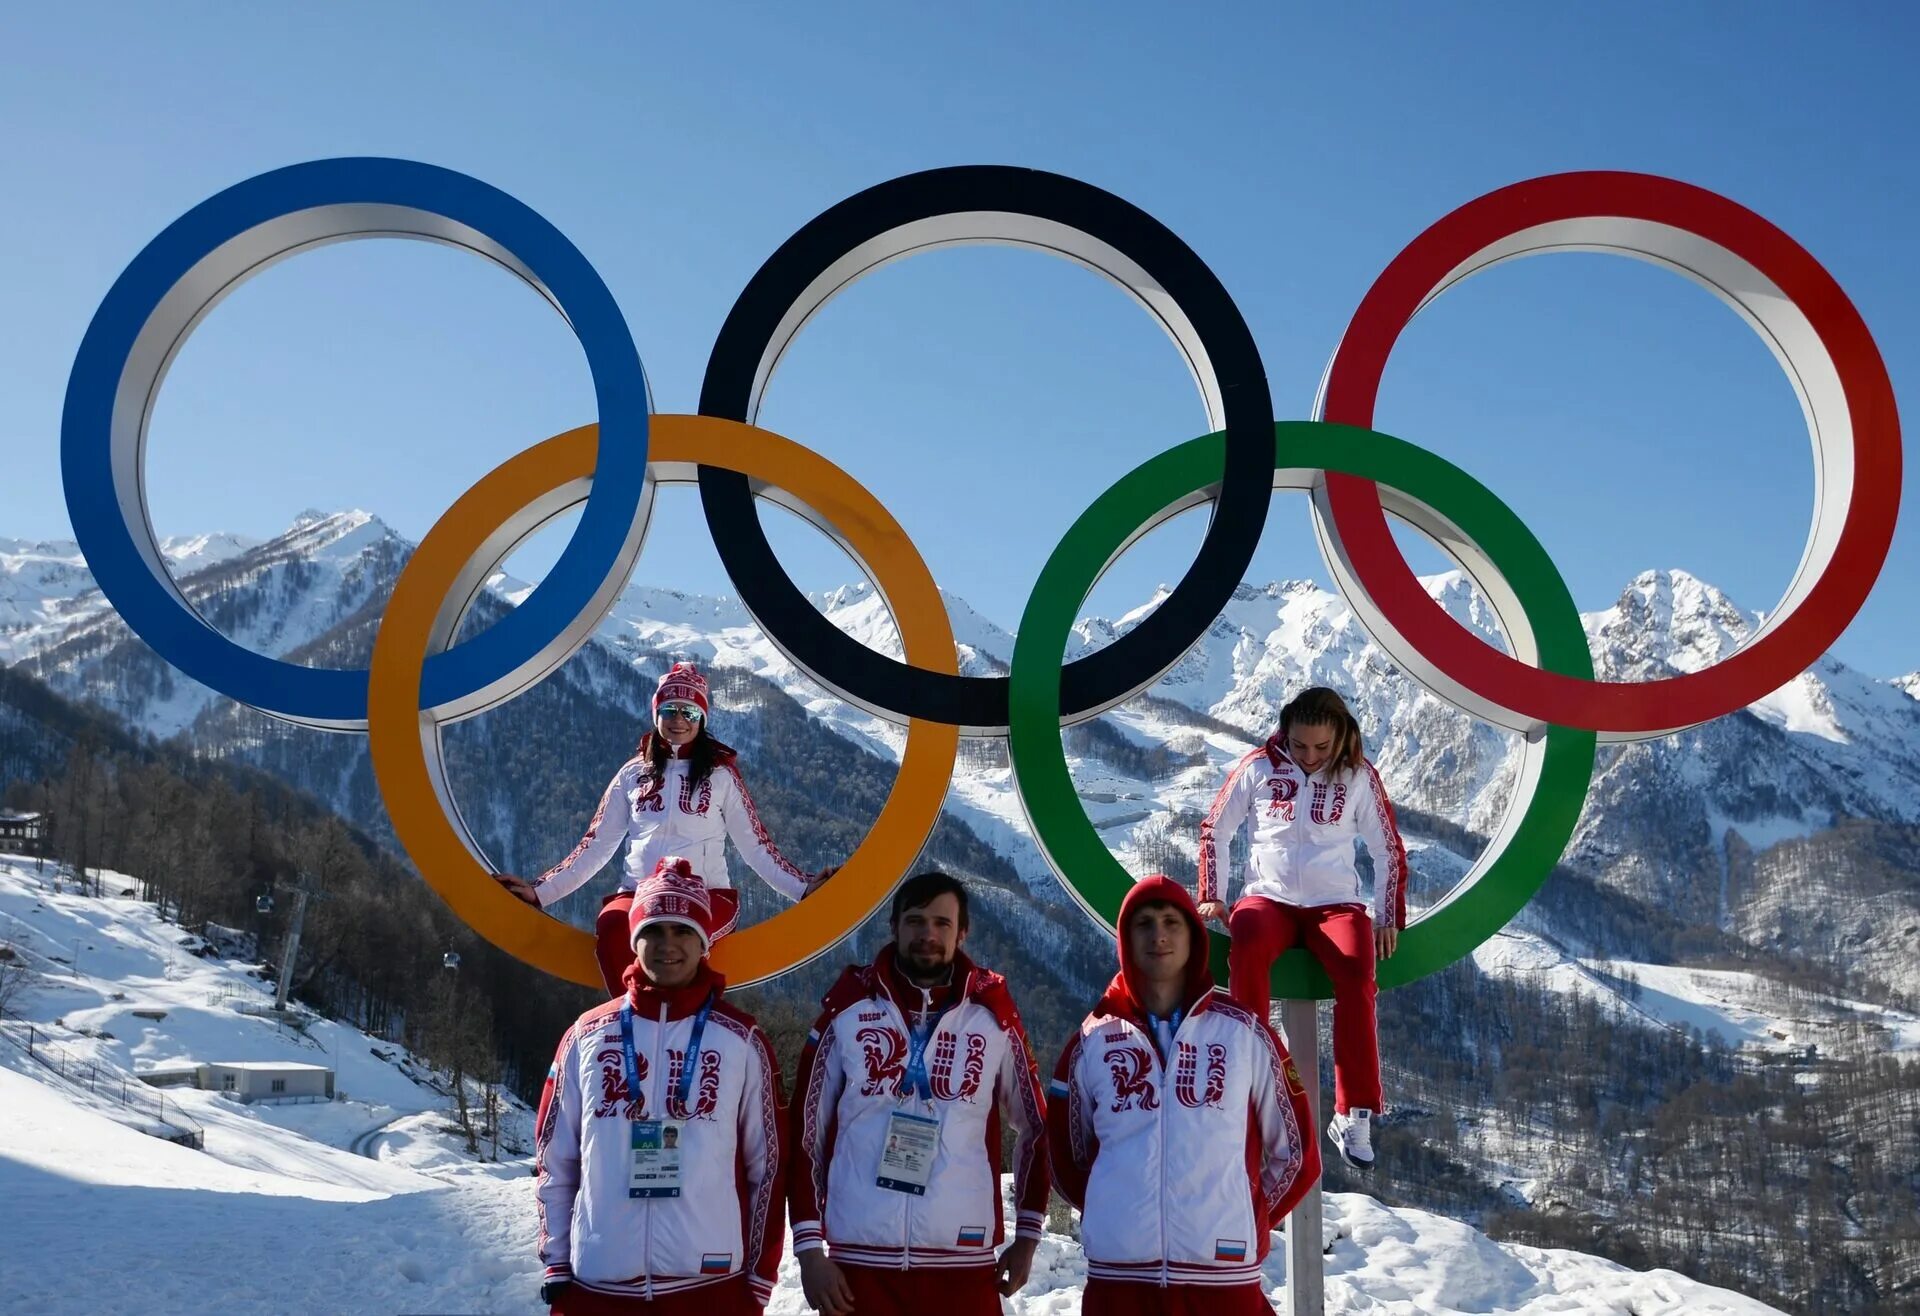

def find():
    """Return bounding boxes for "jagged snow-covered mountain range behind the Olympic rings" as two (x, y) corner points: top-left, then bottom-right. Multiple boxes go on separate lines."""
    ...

(0, 511), (1920, 993)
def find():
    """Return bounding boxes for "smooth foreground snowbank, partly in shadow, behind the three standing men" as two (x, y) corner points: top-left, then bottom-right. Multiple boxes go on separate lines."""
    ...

(0, 1070), (1774, 1316)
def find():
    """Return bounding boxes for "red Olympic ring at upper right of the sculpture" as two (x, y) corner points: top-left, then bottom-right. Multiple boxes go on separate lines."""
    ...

(1319, 171), (1901, 740)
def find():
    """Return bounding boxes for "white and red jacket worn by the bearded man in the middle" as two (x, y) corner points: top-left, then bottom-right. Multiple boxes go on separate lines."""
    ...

(787, 945), (1048, 1270)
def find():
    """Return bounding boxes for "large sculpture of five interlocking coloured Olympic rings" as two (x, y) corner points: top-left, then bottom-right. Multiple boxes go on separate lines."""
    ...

(61, 159), (1901, 997)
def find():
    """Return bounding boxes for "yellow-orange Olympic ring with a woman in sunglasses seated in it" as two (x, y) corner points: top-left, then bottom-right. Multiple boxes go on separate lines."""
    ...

(367, 415), (960, 987)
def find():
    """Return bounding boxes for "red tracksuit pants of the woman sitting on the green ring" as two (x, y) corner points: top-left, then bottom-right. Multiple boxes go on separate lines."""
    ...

(1227, 895), (1380, 1114)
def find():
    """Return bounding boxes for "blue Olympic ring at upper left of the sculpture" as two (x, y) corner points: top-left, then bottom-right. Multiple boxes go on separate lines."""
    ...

(60, 158), (651, 728)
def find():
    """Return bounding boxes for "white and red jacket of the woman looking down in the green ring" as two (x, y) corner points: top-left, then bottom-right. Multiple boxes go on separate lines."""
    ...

(1200, 736), (1407, 928)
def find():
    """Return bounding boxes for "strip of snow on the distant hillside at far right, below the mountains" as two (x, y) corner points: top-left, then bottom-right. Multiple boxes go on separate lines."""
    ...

(1473, 930), (1920, 1053)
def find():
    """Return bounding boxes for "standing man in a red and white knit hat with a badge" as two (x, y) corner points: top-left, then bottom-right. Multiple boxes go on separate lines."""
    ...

(536, 855), (783, 1316)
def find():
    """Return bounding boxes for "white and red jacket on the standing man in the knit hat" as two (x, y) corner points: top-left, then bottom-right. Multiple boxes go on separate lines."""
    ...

(534, 964), (785, 1306)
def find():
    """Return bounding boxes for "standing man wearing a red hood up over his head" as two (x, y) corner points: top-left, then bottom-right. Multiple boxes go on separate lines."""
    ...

(1046, 874), (1319, 1316)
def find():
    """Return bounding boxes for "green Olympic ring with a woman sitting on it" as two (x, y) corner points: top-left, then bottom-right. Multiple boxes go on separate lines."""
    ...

(1008, 421), (1597, 999)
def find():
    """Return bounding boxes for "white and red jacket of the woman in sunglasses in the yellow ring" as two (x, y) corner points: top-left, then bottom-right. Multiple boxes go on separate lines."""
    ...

(534, 736), (808, 914)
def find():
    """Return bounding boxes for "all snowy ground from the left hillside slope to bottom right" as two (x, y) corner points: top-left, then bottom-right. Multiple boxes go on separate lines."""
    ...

(0, 857), (1772, 1316)
